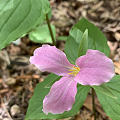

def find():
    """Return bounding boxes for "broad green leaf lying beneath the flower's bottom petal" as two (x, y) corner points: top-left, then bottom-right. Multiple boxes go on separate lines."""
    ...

(25, 74), (90, 120)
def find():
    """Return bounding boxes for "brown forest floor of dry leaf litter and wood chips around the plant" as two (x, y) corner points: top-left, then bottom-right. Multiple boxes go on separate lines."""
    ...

(0, 0), (120, 120)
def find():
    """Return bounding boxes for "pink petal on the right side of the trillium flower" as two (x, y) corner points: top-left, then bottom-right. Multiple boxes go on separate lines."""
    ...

(75, 50), (115, 85)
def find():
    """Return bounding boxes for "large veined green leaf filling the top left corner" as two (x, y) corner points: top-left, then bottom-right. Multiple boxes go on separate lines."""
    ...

(0, 0), (50, 49)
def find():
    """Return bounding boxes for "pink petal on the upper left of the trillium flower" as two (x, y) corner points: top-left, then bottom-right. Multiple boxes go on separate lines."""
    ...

(30, 45), (73, 76)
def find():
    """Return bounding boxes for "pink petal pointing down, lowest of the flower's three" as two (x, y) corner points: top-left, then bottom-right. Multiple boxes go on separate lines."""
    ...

(43, 77), (77, 114)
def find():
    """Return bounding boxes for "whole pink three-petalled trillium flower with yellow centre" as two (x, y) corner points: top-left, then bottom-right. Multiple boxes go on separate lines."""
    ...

(30, 45), (115, 114)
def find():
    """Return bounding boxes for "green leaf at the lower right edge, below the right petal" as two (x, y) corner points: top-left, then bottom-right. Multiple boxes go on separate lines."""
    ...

(93, 75), (120, 120)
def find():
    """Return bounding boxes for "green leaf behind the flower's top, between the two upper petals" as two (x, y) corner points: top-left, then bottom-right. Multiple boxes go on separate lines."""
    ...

(65, 18), (110, 64)
